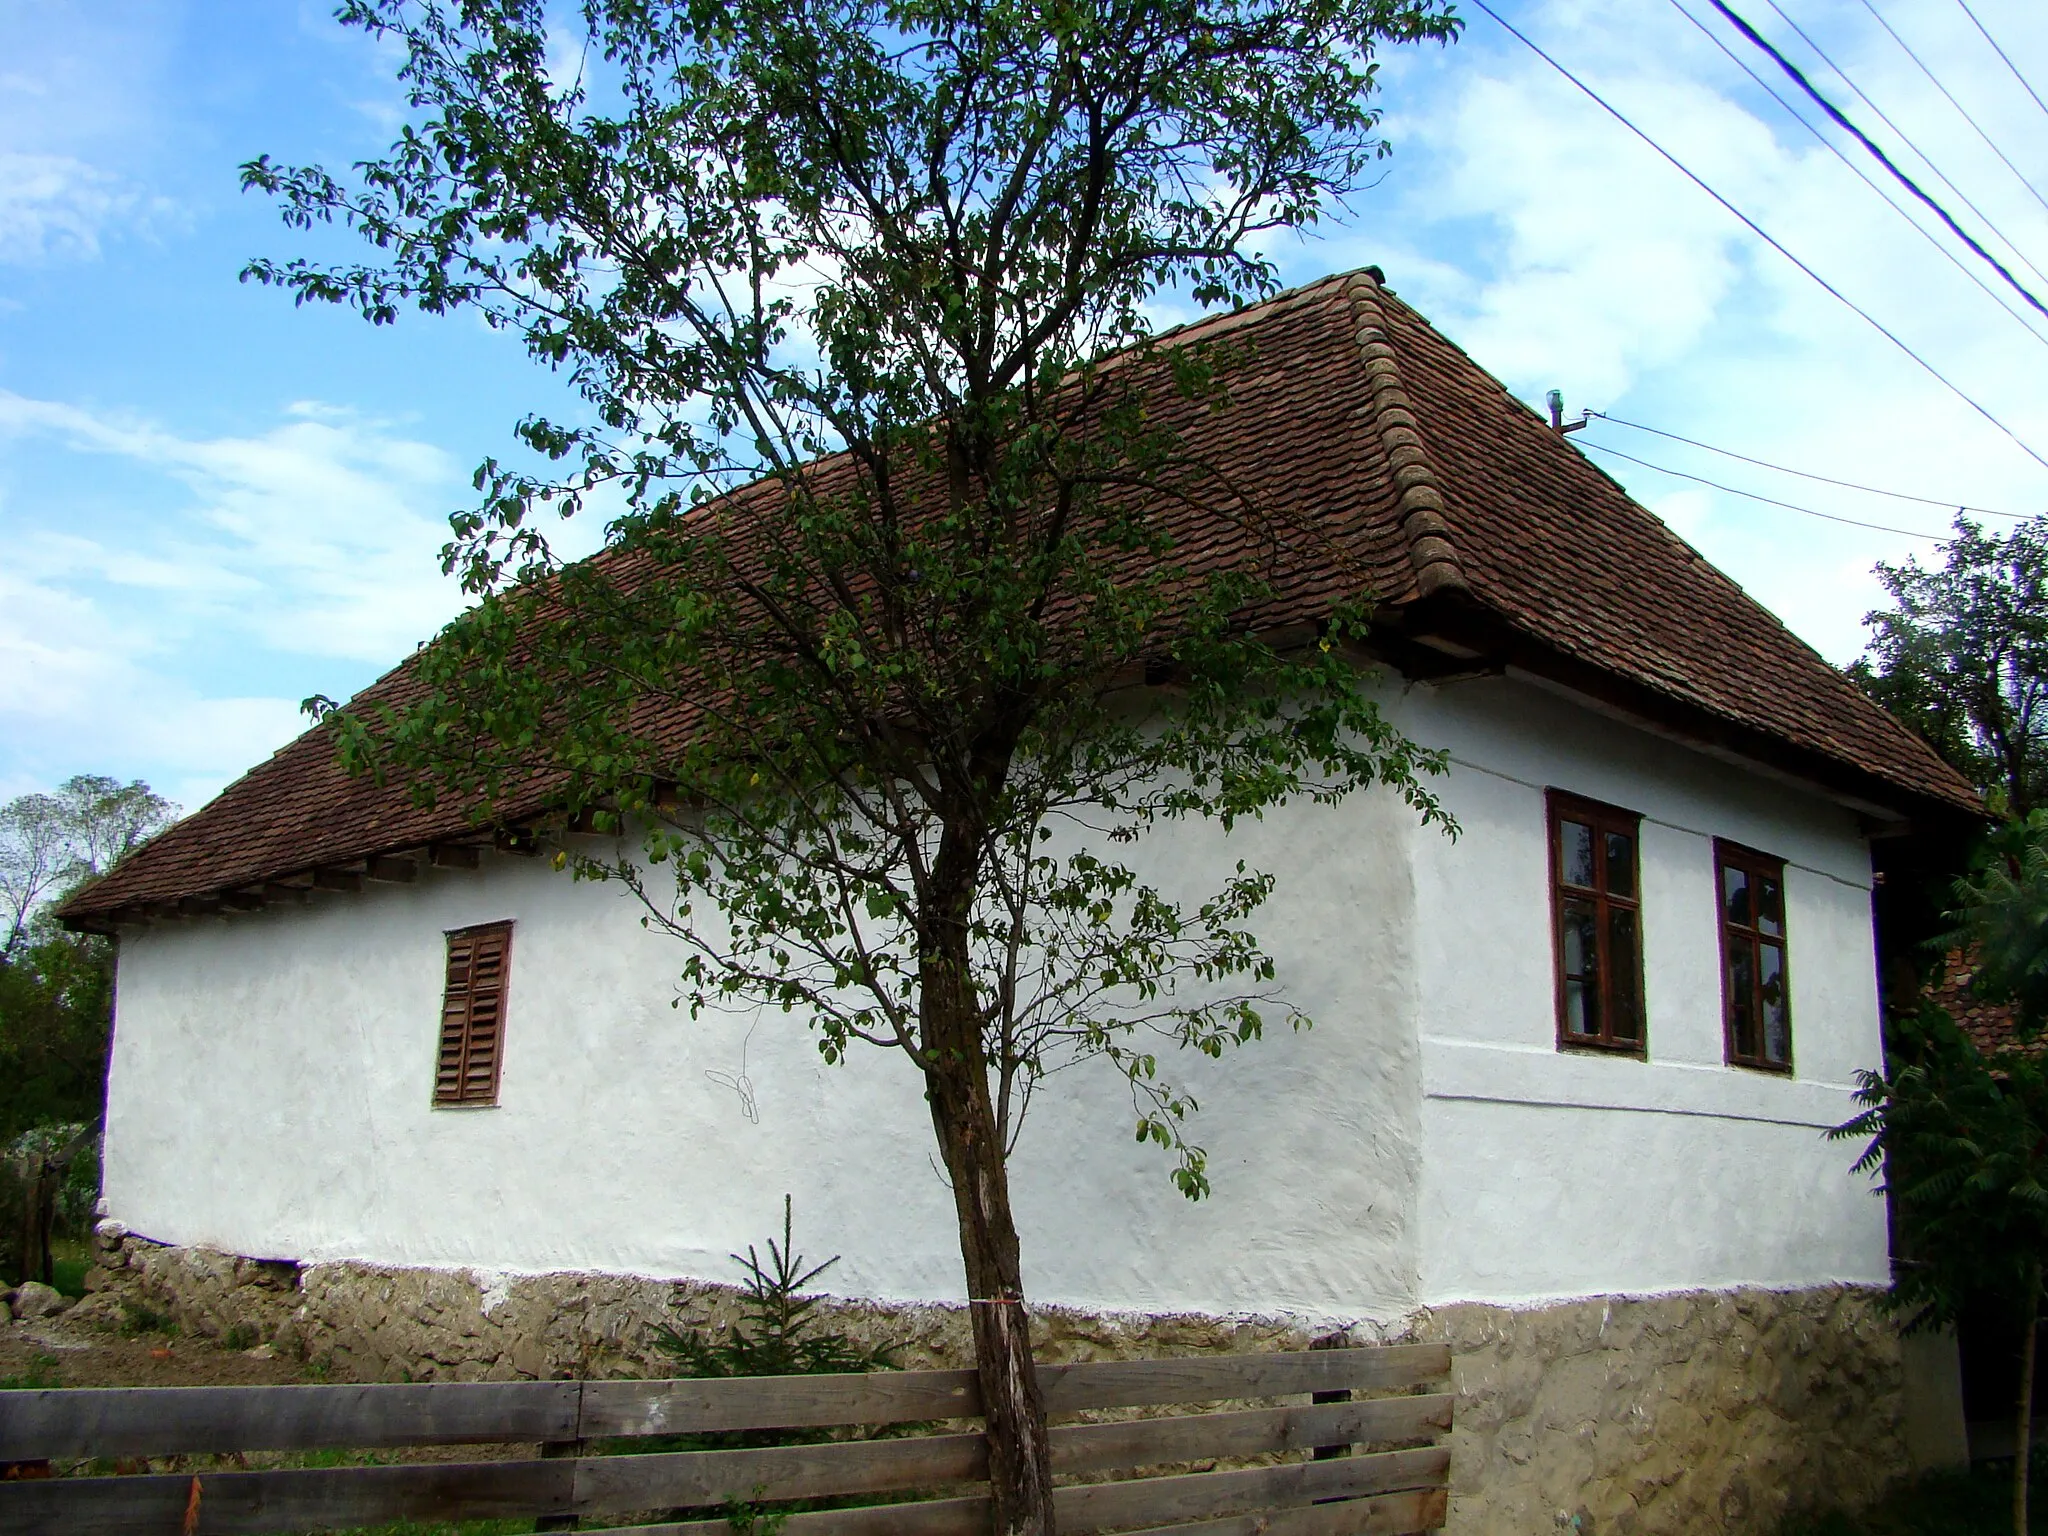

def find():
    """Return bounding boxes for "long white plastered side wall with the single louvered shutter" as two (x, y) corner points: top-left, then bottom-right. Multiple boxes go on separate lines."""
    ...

(106, 757), (1421, 1319)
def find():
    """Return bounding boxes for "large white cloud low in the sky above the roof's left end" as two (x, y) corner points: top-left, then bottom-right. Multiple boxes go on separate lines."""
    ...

(0, 393), (467, 803)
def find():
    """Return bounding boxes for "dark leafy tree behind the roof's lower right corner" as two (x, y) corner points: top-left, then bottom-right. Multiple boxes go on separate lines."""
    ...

(1849, 516), (2048, 817)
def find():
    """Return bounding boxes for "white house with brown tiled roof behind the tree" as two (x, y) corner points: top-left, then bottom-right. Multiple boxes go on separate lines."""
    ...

(66, 270), (1976, 1532)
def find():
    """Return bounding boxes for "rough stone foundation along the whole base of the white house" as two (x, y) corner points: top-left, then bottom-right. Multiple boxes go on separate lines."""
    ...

(76, 1225), (1911, 1536)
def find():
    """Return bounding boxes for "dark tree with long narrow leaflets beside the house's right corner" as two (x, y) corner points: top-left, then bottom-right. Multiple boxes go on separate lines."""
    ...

(1829, 811), (2048, 1536)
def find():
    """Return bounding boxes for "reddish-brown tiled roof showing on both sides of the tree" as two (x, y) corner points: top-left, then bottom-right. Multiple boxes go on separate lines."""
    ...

(63, 272), (1976, 924)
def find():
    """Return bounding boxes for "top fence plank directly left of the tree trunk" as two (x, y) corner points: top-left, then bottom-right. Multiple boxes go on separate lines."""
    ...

(584, 1370), (981, 1440)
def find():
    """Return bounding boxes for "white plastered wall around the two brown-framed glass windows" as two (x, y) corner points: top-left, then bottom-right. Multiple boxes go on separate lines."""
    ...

(1403, 678), (1888, 1303)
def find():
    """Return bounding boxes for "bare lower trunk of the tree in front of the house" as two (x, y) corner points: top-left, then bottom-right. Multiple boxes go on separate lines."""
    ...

(924, 987), (1053, 1536)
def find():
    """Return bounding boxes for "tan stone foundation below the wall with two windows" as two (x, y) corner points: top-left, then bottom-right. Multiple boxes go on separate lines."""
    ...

(1413, 1286), (1911, 1536)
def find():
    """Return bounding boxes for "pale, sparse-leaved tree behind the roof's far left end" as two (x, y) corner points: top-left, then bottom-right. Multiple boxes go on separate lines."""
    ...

(0, 774), (178, 958)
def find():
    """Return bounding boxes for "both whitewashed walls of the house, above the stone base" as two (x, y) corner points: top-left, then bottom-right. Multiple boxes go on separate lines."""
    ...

(106, 682), (1884, 1319)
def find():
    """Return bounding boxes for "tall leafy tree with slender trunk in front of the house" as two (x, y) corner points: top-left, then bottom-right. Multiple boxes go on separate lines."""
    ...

(244, 0), (1456, 1532)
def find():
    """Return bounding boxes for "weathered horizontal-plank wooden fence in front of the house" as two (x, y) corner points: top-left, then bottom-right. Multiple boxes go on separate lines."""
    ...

(0, 1343), (1450, 1536)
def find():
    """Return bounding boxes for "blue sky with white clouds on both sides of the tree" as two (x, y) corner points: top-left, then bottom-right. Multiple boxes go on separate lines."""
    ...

(0, 0), (2048, 809)
